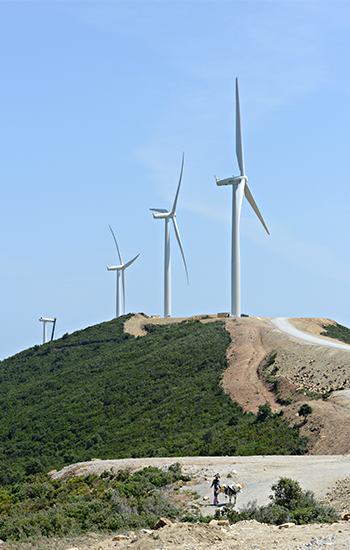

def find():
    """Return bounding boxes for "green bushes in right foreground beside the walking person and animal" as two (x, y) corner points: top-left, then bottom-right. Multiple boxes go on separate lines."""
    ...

(224, 477), (339, 525)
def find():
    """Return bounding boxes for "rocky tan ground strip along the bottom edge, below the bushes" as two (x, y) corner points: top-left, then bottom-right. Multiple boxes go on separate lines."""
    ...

(4, 520), (350, 550)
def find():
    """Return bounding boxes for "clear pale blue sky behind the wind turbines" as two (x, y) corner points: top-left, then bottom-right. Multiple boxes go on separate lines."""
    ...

(0, 0), (350, 359)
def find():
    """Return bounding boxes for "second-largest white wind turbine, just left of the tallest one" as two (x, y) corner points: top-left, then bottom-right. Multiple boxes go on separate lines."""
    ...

(150, 154), (189, 317)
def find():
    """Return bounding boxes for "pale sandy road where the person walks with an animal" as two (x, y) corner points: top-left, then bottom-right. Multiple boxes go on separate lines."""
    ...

(52, 455), (350, 512)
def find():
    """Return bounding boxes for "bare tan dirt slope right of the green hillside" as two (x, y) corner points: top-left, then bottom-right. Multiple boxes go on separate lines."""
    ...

(125, 314), (350, 454)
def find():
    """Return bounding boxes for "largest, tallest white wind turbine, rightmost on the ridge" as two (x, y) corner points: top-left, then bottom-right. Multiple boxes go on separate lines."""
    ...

(215, 78), (270, 317)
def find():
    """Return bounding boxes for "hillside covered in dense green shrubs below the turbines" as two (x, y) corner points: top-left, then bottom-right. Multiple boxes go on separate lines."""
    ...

(0, 316), (306, 483)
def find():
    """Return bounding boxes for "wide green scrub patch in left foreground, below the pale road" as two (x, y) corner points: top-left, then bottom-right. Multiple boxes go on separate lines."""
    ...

(0, 465), (188, 540)
